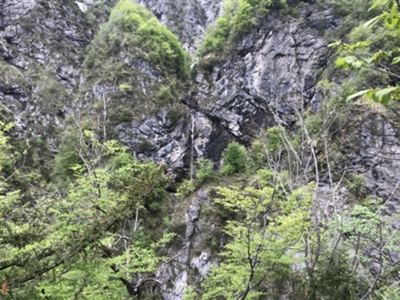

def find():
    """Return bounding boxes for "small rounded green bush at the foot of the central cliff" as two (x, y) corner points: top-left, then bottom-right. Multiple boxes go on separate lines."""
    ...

(221, 142), (248, 175)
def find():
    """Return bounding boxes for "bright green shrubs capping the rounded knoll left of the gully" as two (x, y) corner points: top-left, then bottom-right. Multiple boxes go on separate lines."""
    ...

(85, 0), (189, 80)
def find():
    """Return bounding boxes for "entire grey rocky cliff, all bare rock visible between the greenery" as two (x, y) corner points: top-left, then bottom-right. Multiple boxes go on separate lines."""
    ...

(0, 0), (400, 300)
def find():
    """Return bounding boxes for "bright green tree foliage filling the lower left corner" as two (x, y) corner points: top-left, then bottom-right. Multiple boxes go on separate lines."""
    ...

(0, 124), (172, 300)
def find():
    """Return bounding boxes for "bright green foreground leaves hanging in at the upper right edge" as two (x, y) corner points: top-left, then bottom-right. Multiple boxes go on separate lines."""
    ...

(330, 0), (400, 105)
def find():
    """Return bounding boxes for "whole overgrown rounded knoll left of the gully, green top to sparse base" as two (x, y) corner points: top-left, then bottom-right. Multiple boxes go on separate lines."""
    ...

(81, 0), (190, 124)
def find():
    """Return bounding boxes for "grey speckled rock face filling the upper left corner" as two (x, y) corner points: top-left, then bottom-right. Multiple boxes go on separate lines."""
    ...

(0, 0), (93, 137)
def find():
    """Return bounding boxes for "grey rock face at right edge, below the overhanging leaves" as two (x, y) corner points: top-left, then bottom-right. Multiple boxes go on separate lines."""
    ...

(343, 104), (400, 215)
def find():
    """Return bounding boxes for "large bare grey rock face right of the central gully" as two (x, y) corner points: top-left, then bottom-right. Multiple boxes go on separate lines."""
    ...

(187, 15), (326, 156)
